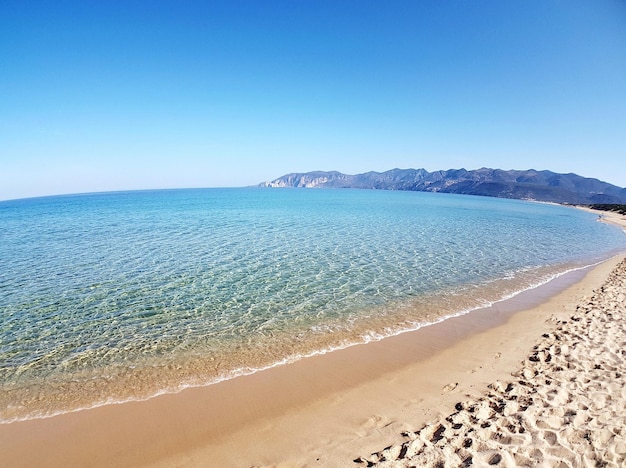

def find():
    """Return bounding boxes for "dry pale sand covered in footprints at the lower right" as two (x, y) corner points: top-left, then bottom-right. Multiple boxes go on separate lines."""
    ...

(355, 260), (626, 467)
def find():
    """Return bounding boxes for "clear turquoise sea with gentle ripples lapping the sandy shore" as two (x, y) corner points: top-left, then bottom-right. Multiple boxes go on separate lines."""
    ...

(0, 188), (626, 422)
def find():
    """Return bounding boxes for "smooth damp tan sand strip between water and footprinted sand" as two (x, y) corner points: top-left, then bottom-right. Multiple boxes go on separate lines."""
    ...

(0, 249), (618, 466)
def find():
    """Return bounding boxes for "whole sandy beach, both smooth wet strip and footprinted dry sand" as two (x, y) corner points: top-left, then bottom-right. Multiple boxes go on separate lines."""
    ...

(0, 213), (626, 467)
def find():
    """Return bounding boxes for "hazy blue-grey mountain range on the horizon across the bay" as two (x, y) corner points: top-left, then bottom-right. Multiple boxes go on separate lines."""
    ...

(259, 167), (626, 205)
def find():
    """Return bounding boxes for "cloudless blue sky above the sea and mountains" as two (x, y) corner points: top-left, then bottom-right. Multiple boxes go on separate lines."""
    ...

(0, 0), (626, 199)
